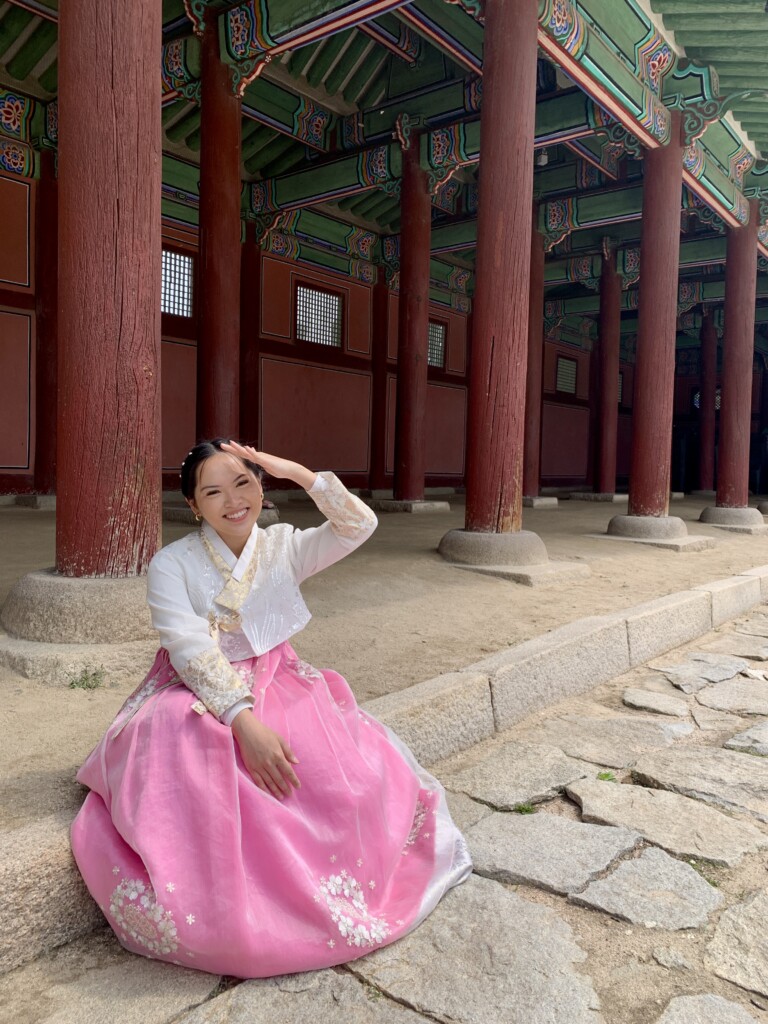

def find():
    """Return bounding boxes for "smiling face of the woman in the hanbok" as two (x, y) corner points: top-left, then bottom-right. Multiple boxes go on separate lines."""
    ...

(189, 452), (263, 555)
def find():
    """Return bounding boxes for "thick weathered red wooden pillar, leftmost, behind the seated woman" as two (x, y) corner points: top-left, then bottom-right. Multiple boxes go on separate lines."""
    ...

(56, 0), (162, 577)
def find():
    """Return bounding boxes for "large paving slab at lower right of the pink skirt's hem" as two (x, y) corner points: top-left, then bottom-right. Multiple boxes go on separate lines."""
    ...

(349, 876), (603, 1024)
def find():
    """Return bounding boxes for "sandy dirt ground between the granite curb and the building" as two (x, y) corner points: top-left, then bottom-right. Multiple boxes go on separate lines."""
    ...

(0, 499), (768, 827)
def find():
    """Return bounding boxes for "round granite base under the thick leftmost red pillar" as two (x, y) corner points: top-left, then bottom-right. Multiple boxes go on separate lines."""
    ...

(0, 569), (157, 644)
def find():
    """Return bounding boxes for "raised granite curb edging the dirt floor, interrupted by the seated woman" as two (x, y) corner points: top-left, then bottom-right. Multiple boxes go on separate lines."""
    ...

(0, 565), (768, 973)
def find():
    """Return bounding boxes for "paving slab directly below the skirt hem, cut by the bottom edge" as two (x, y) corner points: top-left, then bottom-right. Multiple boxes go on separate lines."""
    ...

(175, 971), (434, 1024)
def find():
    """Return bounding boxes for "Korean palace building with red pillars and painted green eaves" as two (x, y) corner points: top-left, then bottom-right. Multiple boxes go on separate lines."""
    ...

(0, 0), (768, 578)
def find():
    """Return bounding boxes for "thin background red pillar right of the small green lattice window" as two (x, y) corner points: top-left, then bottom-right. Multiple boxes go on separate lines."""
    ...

(597, 252), (622, 495)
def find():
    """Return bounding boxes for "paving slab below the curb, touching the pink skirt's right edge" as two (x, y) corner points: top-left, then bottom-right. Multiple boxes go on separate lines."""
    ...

(442, 740), (587, 811)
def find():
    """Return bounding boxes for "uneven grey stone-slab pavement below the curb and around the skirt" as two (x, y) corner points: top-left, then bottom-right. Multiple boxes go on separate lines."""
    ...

(7, 605), (768, 1024)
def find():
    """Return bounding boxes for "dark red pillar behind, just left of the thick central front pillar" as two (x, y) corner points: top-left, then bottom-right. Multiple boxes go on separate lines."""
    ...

(394, 136), (432, 501)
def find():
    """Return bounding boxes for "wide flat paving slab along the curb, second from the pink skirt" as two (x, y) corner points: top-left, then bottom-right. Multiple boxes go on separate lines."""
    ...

(521, 715), (694, 768)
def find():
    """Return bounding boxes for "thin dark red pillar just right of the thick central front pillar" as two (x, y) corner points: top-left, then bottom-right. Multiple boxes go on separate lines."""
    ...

(522, 221), (544, 498)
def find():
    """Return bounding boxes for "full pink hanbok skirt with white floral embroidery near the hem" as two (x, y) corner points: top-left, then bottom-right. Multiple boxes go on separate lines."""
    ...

(72, 643), (471, 978)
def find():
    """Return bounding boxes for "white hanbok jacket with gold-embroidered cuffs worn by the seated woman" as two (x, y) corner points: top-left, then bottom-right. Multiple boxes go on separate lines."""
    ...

(143, 473), (377, 724)
